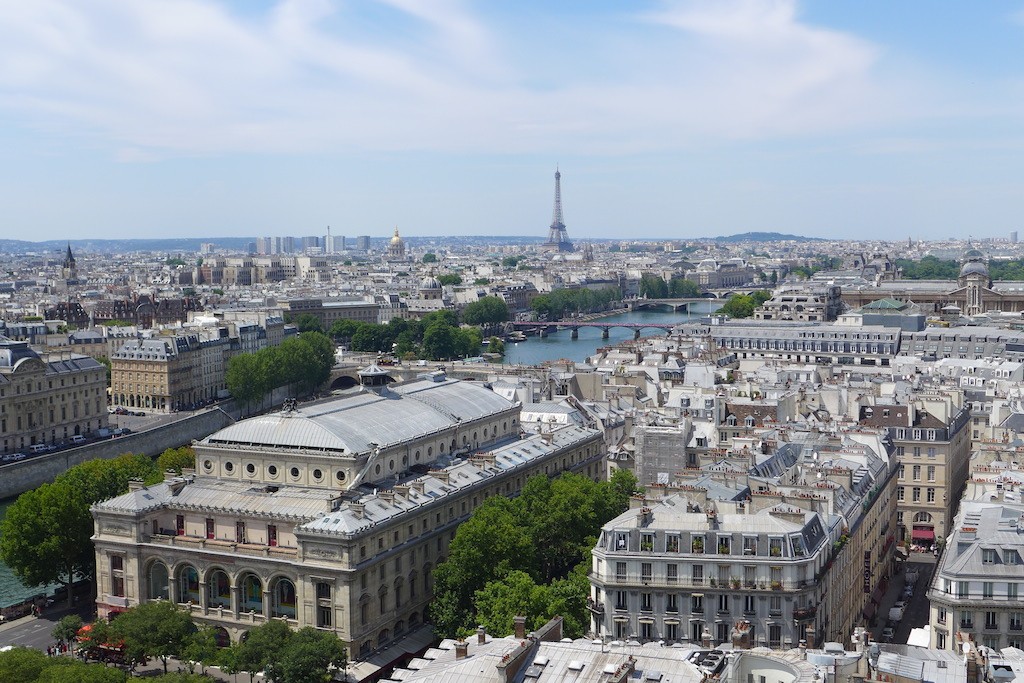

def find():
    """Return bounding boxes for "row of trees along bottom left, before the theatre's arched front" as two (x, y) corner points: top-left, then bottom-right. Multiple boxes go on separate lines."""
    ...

(0, 600), (347, 683)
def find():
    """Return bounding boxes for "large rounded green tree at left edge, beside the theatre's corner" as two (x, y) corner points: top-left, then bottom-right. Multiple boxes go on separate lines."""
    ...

(0, 481), (95, 606)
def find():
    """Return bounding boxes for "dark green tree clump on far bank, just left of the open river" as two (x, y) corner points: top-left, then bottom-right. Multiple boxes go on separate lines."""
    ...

(330, 311), (485, 360)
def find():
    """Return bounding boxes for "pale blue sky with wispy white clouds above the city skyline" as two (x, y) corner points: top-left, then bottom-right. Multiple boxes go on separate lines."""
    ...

(0, 0), (1024, 241)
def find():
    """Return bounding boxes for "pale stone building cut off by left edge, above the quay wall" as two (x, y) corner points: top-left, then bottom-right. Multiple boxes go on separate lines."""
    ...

(0, 337), (106, 455)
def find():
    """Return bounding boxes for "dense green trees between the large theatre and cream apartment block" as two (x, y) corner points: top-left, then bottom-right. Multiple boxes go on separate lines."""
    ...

(430, 470), (637, 637)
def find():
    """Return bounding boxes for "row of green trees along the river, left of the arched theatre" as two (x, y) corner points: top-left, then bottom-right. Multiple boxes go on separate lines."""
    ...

(0, 447), (196, 606)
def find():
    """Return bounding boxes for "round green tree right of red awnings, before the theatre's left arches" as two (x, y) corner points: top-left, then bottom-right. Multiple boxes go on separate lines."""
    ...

(111, 600), (198, 674)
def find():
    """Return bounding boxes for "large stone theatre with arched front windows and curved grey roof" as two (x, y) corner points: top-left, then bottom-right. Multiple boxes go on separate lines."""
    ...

(93, 373), (604, 659)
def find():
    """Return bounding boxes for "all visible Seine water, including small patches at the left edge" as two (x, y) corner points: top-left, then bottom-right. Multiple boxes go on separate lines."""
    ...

(0, 301), (721, 607)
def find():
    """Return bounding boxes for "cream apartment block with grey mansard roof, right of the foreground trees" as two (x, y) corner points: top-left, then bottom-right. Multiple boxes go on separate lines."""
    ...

(590, 434), (897, 649)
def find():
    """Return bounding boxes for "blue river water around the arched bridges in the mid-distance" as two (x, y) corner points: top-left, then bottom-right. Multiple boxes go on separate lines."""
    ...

(505, 301), (723, 365)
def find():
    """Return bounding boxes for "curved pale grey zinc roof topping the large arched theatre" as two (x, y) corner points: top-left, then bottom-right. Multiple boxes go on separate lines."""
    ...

(204, 380), (512, 454)
